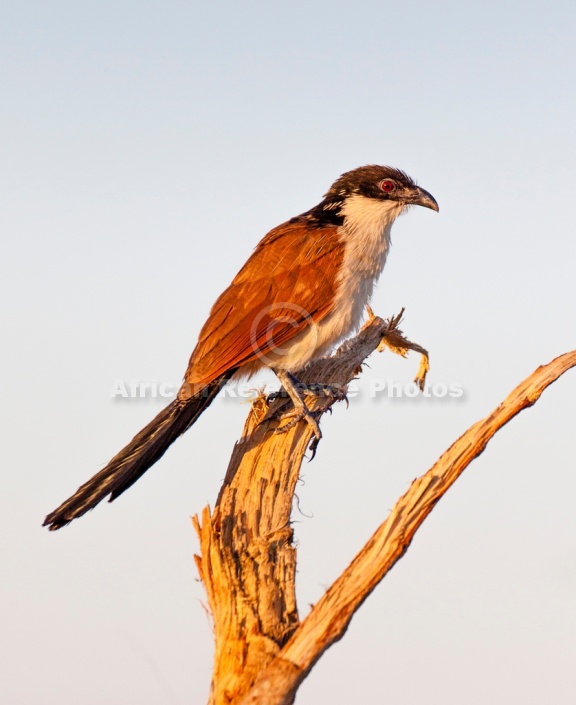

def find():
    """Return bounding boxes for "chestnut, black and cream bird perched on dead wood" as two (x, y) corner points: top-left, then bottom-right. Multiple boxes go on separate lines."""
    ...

(43, 165), (439, 531)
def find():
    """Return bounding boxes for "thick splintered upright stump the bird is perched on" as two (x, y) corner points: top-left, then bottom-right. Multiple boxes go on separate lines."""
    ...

(194, 316), (416, 705)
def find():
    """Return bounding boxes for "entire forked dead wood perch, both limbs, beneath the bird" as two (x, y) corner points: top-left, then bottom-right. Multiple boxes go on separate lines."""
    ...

(194, 310), (576, 705)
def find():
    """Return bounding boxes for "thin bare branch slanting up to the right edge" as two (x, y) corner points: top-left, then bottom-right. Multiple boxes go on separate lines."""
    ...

(241, 351), (576, 705)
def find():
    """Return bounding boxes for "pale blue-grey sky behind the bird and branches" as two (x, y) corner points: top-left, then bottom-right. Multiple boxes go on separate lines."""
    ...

(0, 0), (576, 705)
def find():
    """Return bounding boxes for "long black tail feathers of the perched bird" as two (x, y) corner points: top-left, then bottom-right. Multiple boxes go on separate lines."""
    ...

(43, 372), (232, 531)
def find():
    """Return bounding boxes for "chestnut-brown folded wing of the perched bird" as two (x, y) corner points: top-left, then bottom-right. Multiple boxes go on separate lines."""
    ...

(185, 221), (343, 387)
